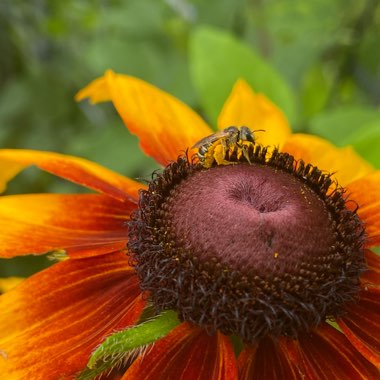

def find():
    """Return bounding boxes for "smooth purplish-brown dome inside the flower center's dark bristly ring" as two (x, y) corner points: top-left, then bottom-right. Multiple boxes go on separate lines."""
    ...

(166, 164), (335, 275)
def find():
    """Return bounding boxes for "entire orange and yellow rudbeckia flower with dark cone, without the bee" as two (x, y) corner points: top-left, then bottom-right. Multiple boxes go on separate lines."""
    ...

(0, 72), (380, 379)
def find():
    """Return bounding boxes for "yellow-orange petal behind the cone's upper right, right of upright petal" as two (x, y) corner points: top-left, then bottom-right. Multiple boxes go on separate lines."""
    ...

(282, 133), (373, 186)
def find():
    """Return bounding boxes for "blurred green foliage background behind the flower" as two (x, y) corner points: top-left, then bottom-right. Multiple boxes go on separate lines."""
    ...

(0, 0), (380, 277)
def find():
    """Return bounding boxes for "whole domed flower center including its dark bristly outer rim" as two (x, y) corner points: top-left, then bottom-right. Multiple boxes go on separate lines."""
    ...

(128, 146), (364, 342)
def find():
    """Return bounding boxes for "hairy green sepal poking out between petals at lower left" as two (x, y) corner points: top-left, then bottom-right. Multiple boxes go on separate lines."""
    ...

(78, 310), (180, 380)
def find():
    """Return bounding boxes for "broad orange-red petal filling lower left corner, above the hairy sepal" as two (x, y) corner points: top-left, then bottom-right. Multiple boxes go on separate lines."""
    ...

(0, 253), (145, 379)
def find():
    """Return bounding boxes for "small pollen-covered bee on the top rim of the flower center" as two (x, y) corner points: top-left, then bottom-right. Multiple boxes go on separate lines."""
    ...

(192, 126), (264, 168)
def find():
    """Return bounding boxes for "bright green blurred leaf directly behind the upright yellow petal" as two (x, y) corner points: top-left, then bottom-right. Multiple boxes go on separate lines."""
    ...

(190, 26), (296, 126)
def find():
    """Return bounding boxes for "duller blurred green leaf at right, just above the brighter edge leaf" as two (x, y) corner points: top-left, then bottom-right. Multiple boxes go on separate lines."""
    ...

(309, 106), (380, 146)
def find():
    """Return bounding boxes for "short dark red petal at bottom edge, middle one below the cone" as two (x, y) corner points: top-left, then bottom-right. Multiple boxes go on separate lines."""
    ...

(238, 338), (302, 380)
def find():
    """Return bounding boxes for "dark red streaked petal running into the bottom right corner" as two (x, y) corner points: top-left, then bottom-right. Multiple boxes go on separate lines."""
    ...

(282, 324), (379, 380)
